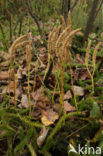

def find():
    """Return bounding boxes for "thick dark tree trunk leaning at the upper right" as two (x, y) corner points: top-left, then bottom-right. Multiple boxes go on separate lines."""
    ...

(83, 0), (99, 44)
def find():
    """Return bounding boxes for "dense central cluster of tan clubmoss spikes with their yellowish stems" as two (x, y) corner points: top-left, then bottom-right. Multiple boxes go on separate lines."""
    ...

(44, 12), (81, 114)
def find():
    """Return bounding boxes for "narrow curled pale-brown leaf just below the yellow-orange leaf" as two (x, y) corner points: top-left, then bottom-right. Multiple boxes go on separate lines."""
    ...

(37, 125), (49, 148)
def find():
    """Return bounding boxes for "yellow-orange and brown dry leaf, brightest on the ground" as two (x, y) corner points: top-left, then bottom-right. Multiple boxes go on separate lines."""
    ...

(41, 109), (59, 126)
